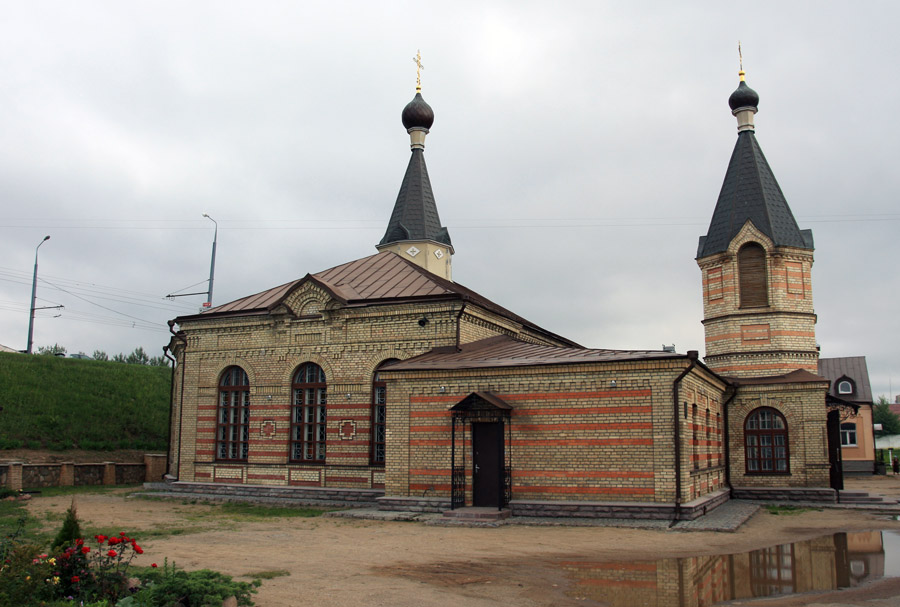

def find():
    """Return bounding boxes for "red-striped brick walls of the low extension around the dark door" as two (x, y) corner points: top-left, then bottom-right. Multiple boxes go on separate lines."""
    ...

(383, 358), (725, 503)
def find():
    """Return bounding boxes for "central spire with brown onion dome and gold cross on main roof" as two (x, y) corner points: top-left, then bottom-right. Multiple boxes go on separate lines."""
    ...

(375, 54), (453, 280)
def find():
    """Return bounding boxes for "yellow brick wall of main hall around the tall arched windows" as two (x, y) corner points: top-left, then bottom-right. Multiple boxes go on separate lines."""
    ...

(173, 300), (460, 488)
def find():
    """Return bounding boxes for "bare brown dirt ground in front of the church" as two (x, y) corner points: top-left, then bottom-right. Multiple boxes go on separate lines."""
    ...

(17, 476), (900, 607)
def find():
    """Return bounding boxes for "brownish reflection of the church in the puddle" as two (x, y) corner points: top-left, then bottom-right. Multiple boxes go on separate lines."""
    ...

(560, 531), (900, 607)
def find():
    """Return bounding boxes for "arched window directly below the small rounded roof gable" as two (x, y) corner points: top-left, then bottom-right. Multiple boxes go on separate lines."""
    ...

(290, 363), (327, 464)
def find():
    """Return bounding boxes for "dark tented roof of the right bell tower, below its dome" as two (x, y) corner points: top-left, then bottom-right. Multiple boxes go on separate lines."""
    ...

(697, 130), (814, 259)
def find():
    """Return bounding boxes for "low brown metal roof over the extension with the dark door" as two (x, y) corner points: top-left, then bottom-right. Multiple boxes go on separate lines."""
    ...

(382, 335), (685, 371)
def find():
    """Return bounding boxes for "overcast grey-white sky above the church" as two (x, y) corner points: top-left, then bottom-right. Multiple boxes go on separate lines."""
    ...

(0, 0), (900, 399)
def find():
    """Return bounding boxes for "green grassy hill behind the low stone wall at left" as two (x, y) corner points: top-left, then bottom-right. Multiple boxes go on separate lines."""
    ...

(0, 352), (172, 450)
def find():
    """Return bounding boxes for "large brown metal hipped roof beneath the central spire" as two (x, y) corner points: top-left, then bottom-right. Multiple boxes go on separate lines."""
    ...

(175, 251), (580, 348)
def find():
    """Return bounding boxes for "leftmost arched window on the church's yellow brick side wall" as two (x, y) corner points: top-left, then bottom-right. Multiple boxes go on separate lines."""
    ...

(216, 367), (250, 461)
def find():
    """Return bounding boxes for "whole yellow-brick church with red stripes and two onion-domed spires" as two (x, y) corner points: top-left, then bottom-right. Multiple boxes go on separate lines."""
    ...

(169, 67), (844, 519)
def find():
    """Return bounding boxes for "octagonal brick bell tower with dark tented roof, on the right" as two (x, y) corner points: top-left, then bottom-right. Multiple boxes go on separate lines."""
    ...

(697, 70), (818, 378)
